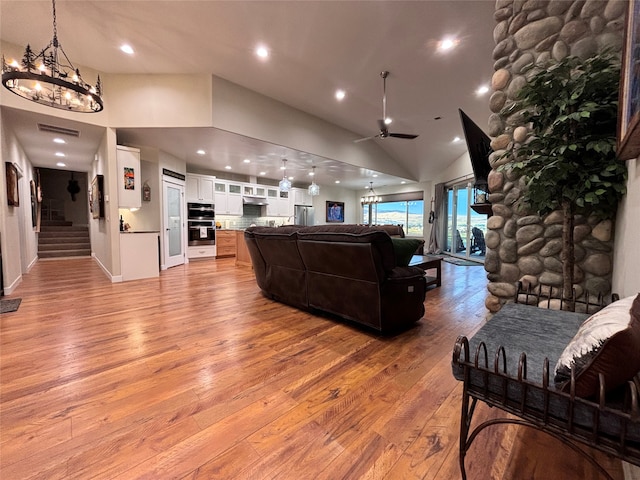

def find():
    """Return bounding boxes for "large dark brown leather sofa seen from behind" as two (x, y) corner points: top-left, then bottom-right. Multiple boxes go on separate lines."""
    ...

(244, 225), (426, 332)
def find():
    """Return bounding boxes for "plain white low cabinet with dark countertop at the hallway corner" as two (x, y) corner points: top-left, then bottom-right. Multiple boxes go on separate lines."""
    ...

(120, 231), (160, 282)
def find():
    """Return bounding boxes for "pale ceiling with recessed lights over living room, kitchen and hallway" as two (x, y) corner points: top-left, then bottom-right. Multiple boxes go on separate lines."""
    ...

(0, 0), (495, 188)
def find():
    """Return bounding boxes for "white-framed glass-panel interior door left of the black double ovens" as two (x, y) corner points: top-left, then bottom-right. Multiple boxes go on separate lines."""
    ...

(162, 180), (185, 268)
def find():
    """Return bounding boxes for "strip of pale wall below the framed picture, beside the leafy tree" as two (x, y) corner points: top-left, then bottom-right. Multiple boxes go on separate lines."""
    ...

(612, 157), (640, 298)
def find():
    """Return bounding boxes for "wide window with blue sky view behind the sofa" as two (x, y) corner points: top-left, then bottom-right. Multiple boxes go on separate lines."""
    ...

(362, 200), (424, 237)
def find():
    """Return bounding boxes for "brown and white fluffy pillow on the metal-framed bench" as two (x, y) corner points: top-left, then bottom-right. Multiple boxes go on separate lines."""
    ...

(555, 294), (640, 397)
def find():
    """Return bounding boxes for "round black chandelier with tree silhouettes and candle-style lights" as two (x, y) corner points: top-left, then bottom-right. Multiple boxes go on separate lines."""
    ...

(2, 0), (103, 113)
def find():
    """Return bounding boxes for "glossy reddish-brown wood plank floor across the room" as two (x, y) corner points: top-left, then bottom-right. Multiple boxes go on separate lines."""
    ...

(0, 258), (622, 480)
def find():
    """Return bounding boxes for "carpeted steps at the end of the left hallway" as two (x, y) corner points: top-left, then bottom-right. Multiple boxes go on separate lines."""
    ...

(38, 220), (91, 258)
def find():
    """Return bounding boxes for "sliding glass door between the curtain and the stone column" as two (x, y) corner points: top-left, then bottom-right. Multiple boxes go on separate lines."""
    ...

(445, 184), (487, 261)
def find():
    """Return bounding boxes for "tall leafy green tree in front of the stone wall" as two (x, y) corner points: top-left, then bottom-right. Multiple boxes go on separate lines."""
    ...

(502, 53), (627, 298)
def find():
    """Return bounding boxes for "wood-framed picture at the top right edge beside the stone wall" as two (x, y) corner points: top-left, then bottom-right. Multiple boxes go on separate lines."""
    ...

(617, 0), (640, 160)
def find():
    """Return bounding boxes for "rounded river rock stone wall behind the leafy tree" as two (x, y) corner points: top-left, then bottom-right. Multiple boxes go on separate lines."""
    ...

(485, 0), (628, 312)
